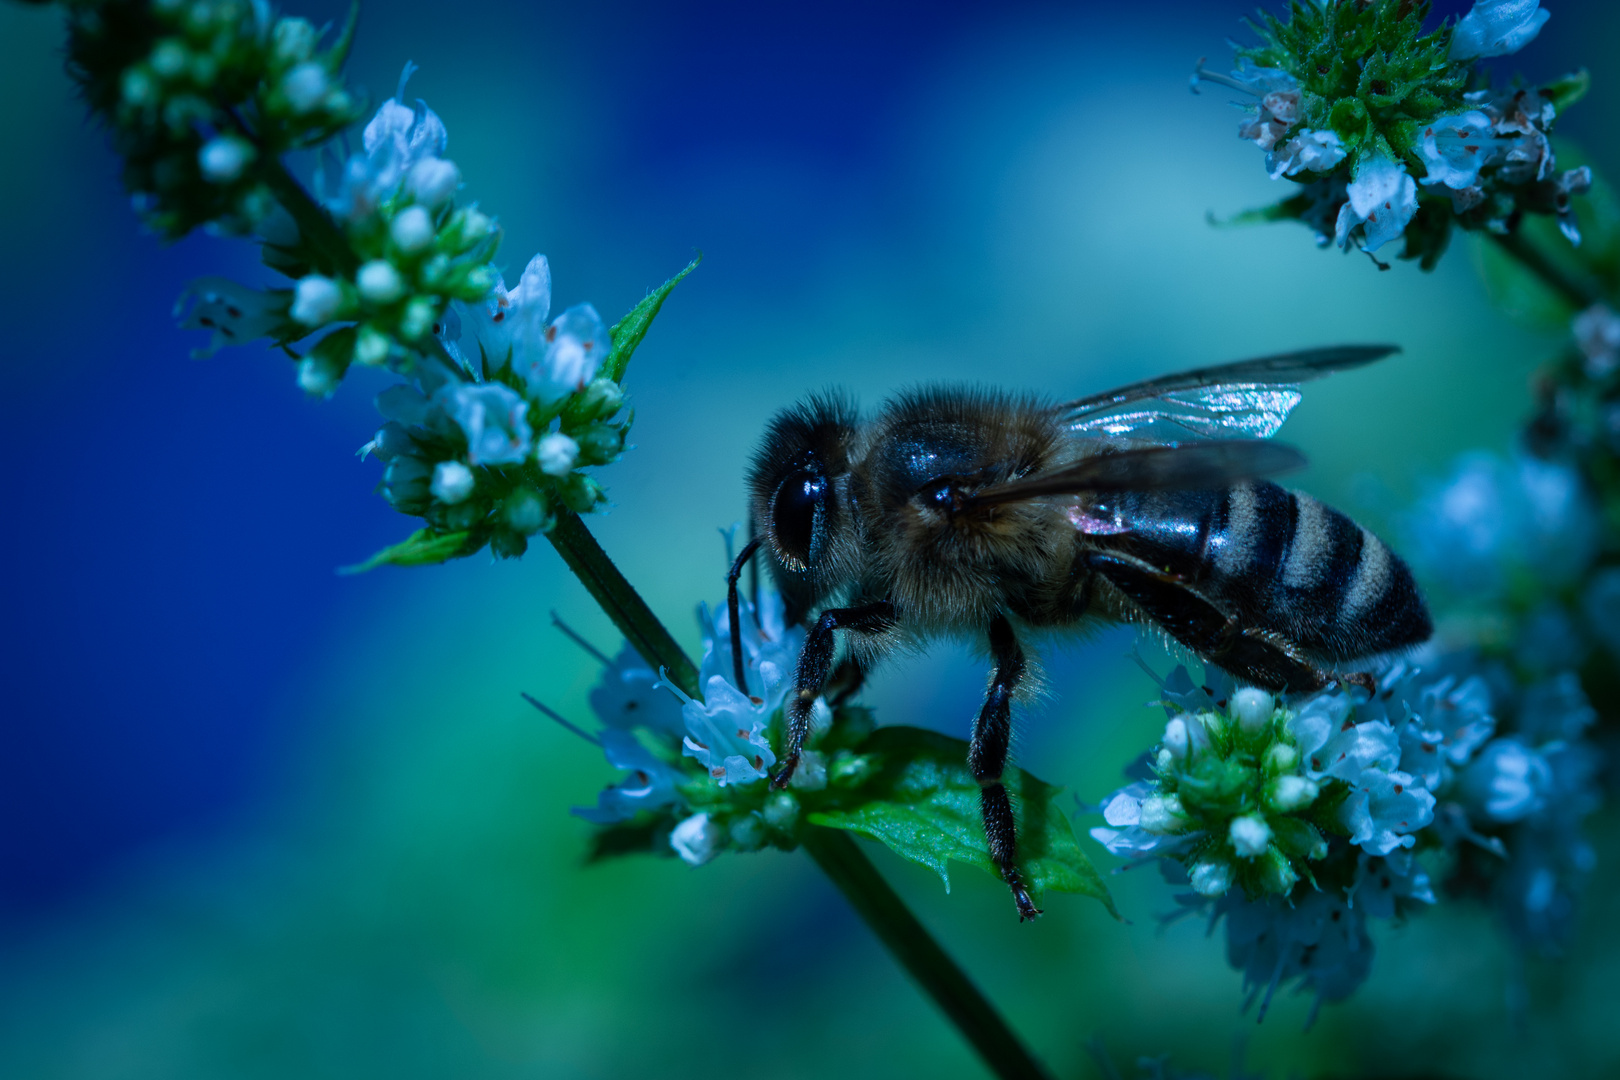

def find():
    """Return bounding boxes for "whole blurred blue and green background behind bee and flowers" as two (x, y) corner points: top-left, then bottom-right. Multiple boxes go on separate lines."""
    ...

(0, 0), (1620, 1078)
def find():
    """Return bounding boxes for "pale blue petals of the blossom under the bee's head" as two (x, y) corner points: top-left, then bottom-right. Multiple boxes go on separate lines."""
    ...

(573, 579), (810, 866)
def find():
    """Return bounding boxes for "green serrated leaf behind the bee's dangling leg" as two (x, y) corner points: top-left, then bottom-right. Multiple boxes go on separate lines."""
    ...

(808, 727), (1118, 916)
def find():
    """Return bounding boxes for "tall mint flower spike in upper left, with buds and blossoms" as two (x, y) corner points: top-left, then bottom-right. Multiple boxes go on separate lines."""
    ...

(70, 0), (695, 568)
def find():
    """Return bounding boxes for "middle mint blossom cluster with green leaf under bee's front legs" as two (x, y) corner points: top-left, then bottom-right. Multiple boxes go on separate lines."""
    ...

(541, 566), (1113, 910)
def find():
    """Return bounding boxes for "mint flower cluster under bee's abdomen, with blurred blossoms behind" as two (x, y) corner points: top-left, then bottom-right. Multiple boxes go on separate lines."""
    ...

(1092, 657), (1596, 1018)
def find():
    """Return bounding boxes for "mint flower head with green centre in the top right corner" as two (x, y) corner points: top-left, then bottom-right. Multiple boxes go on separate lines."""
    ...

(1192, 0), (1592, 269)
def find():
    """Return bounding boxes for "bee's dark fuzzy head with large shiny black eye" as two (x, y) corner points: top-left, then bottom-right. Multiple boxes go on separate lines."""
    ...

(748, 393), (857, 609)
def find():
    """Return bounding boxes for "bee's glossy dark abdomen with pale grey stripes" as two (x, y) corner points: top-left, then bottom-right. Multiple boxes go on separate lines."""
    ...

(1094, 481), (1434, 661)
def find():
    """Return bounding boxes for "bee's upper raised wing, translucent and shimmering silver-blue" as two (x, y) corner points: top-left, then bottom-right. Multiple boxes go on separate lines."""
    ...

(1058, 345), (1400, 442)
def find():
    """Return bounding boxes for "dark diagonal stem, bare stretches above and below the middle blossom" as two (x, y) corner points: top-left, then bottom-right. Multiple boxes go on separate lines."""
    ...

(546, 510), (1050, 1080)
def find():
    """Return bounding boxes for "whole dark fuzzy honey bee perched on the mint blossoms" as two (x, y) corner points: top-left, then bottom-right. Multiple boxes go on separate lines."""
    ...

(729, 345), (1432, 921)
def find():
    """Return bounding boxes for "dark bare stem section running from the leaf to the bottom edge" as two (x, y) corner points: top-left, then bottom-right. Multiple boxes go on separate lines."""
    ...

(800, 826), (1051, 1080)
